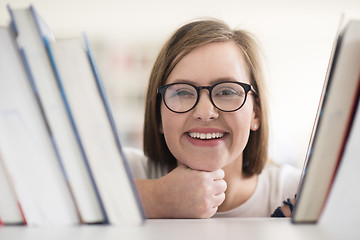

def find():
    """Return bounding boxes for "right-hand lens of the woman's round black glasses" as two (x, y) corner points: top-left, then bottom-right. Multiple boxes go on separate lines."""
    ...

(211, 83), (246, 111)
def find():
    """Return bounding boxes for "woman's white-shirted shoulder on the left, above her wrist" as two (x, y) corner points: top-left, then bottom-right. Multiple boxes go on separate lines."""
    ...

(123, 147), (166, 179)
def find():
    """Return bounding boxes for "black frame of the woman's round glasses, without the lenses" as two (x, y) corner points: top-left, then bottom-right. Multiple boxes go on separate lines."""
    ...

(157, 81), (257, 113)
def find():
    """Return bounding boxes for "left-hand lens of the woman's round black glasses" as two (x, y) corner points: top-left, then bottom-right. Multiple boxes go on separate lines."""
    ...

(164, 83), (197, 112)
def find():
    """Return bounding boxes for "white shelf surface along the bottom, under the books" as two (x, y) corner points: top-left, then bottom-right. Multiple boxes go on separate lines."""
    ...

(0, 218), (360, 240)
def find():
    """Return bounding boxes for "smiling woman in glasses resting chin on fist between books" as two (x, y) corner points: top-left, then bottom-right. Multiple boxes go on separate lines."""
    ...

(126, 20), (300, 218)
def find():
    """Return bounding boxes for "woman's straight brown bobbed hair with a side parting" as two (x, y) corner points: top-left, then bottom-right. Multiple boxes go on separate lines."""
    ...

(144, 19), (269, 174)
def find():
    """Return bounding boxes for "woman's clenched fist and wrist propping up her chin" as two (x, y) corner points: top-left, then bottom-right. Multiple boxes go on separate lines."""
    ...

(136, 165), (227, 218)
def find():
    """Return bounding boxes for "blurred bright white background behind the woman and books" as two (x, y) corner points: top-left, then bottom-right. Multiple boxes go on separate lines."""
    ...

(0, 0), (360, 167)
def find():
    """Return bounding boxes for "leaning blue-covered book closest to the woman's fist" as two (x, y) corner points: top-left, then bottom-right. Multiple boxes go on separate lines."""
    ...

(48, 38), (144, 225)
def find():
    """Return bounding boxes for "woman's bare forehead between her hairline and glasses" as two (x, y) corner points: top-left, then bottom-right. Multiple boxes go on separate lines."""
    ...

(166, 41), (250, 85)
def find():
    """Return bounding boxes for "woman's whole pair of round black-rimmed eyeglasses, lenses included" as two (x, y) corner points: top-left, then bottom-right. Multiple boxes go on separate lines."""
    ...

(157, 81), (256, 113)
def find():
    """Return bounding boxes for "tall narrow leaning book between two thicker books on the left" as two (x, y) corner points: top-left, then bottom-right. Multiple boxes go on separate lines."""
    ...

(10, 6), (107, 223)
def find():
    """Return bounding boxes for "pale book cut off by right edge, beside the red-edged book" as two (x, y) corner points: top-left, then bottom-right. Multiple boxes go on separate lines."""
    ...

(320, 93), (360, 224)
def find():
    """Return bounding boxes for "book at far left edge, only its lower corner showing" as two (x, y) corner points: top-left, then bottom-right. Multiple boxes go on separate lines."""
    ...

(0, 144), (26, 225)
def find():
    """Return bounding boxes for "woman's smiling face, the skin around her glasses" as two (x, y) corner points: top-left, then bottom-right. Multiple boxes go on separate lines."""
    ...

(161, 41), (260, 171)
